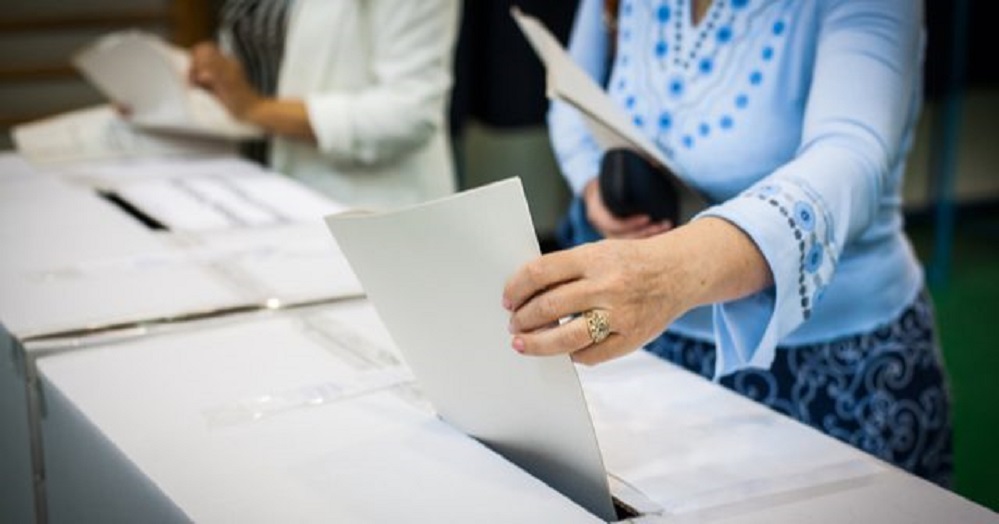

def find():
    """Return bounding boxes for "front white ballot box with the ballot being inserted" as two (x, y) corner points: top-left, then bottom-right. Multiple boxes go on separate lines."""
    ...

(37, 301), (997, 523)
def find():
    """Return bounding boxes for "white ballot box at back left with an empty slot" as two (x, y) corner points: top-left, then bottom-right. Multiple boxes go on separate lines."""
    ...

(0, 154), (362, 521)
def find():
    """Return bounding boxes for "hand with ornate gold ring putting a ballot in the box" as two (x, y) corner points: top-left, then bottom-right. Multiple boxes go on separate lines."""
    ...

(503, 235), (689, 364)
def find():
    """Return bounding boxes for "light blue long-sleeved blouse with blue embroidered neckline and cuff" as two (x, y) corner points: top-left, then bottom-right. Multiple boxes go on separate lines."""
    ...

(548, 0), (924, 376)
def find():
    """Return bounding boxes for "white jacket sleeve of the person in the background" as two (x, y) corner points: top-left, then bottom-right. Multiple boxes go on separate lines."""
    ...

(305, 0), (459, 164)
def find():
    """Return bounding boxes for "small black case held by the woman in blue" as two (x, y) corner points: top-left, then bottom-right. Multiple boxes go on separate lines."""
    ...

(598, 149), (680, 225)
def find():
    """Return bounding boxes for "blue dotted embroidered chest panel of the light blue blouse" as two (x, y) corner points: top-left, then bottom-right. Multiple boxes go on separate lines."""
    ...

(608, 0), (789, 157)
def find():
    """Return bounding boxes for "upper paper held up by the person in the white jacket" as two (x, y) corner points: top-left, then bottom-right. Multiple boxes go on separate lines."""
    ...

(72, 30), (261, 139)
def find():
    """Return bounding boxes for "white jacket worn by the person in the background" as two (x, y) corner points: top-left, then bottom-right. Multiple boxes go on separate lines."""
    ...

(271, 0), (460, 209)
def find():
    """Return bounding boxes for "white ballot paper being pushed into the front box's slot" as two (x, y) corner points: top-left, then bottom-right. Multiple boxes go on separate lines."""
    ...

(326, 178), (617, 520)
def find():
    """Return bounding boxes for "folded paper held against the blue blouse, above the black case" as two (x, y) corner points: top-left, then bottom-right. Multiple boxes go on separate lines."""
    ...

(511, 7), (707, 222)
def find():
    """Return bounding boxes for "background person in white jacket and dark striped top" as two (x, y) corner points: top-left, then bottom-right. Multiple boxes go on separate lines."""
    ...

(190, 0), (460, 208)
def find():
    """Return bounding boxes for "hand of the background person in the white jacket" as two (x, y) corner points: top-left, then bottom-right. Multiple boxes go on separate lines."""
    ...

(189, 42), (265, 120)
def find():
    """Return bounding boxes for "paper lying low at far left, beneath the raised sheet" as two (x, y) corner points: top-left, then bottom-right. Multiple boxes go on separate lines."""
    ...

(11, 105), (236, 164)
